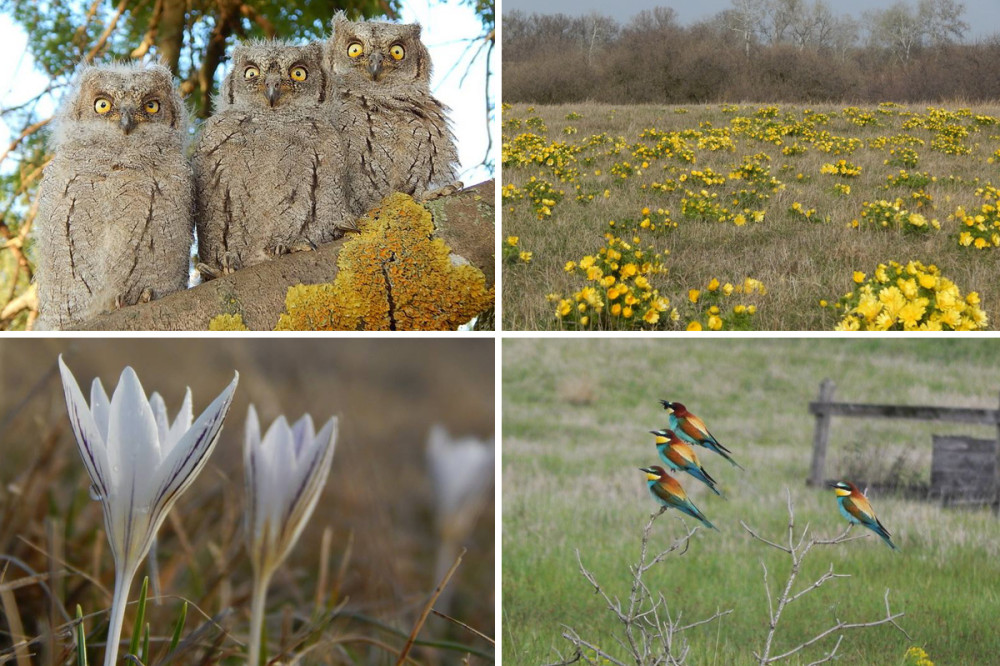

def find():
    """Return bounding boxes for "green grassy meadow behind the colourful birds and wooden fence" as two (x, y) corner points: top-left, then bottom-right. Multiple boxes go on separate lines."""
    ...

(501, 338), (1000, 666)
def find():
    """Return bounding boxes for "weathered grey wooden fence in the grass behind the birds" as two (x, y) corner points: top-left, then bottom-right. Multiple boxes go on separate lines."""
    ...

(807, 379), (1000, 502)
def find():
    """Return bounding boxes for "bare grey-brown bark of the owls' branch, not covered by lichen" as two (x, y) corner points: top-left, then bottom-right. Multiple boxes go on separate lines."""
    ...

(68, 180), (496, 331)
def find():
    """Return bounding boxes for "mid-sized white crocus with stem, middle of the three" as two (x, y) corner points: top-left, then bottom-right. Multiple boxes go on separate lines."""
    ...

(243, 405), (337, 666)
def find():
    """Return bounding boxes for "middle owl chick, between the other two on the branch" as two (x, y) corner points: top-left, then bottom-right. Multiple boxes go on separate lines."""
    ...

(194, 41), (353, 277)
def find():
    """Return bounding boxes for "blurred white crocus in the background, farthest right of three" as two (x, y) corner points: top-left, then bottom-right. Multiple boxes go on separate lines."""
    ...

(427, 425), (493, 613)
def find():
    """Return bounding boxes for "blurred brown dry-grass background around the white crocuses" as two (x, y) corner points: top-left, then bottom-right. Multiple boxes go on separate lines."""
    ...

(0, 339), (495, 666)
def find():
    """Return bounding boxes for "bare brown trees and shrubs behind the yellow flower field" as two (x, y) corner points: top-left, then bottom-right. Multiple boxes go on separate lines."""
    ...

(502, 0), (1000, 104)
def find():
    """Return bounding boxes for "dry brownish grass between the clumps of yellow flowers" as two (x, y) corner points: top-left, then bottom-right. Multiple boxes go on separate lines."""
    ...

(503, 104), (1000, 330)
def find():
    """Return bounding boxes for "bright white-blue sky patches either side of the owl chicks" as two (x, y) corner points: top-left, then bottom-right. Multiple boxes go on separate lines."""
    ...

(0, 0), (498, 185)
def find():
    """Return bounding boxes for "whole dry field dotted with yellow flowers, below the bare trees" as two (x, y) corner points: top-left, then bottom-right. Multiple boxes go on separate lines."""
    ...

(502, 103), (1000, 330)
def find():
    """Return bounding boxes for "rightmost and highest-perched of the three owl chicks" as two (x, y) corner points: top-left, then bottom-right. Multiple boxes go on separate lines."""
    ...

(326, 12), (462, 215)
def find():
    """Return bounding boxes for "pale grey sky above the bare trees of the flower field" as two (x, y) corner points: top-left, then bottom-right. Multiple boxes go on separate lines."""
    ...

(503, 0), (1000, 38)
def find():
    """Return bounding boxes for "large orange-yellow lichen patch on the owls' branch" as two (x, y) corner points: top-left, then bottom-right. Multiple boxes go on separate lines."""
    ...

(275, 194), (494, 331)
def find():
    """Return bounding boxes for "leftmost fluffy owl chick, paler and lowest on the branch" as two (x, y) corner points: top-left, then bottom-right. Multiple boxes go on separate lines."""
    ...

(35, 63), (194, 330)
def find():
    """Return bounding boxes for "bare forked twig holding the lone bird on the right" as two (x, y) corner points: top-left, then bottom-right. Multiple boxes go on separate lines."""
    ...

(740, 489), (909, 666)
